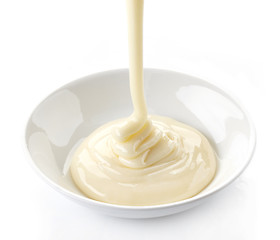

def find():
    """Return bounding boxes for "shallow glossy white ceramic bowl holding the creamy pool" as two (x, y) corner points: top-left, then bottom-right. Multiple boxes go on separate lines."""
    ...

(25, 69), (256, 218)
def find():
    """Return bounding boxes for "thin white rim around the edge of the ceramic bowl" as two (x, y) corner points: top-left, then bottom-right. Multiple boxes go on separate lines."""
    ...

(23, 68), (257, 211)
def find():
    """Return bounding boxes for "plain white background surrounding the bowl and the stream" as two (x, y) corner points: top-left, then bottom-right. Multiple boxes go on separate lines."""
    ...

(0, 0), (280, 240)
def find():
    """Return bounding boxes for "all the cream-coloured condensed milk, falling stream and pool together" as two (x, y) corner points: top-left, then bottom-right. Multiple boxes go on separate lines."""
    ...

(71, 0), (216, 206)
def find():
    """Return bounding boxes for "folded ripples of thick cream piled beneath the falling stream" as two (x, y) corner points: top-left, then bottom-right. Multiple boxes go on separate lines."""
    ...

(109, 120), (180, 168)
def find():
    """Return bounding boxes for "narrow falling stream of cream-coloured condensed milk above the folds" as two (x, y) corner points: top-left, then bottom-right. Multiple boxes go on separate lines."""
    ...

(114, 0), (148, 141)
